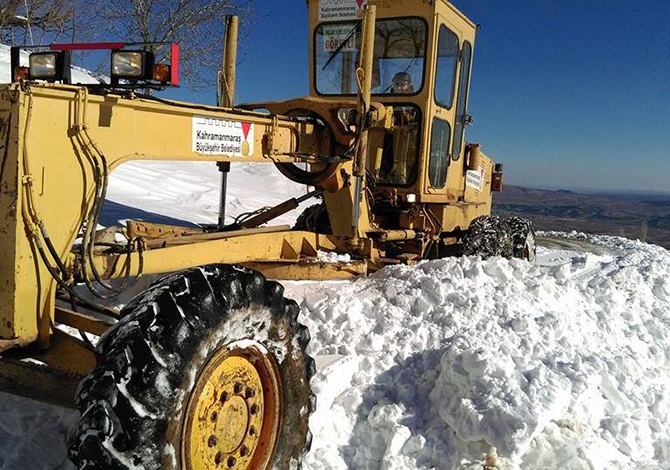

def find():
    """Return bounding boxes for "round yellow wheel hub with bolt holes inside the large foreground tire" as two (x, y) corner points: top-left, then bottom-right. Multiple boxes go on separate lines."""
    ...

(181, 346), (281, 470)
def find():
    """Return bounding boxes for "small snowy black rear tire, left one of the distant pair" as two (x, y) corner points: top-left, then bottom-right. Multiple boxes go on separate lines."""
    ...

(461, 215), (512, 258)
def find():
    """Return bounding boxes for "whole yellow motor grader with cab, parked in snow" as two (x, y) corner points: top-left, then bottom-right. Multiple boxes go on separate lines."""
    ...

(0, 0), (535, 469)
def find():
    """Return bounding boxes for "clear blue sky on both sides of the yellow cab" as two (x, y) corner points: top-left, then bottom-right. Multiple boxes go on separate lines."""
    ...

(169, 0), (670, 192)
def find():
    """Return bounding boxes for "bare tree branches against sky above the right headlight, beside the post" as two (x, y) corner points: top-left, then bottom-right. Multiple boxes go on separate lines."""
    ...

(88, 0), (252, 88)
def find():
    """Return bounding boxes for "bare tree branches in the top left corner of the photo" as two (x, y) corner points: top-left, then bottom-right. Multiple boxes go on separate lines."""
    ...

(0, 0), (74, 45)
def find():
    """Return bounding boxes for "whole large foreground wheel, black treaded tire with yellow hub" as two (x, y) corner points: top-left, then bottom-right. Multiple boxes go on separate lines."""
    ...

(69, 265), (316, 470)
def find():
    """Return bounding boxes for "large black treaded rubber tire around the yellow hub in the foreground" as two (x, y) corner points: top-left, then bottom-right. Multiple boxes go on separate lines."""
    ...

(69, 264), (316, 470)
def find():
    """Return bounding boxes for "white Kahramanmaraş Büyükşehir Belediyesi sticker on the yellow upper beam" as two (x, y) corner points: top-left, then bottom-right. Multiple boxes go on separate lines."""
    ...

(192, 116), (254, 157)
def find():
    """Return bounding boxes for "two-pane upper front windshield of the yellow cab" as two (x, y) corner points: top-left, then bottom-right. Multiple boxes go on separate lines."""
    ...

(314, 19), (426, 95)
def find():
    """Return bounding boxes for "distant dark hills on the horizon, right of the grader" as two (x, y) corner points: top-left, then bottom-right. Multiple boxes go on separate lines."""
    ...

(493, 185), (670, 249)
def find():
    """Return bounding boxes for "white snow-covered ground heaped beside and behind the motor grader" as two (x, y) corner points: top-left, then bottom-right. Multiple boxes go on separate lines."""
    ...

(0, 162), (670, 470)
